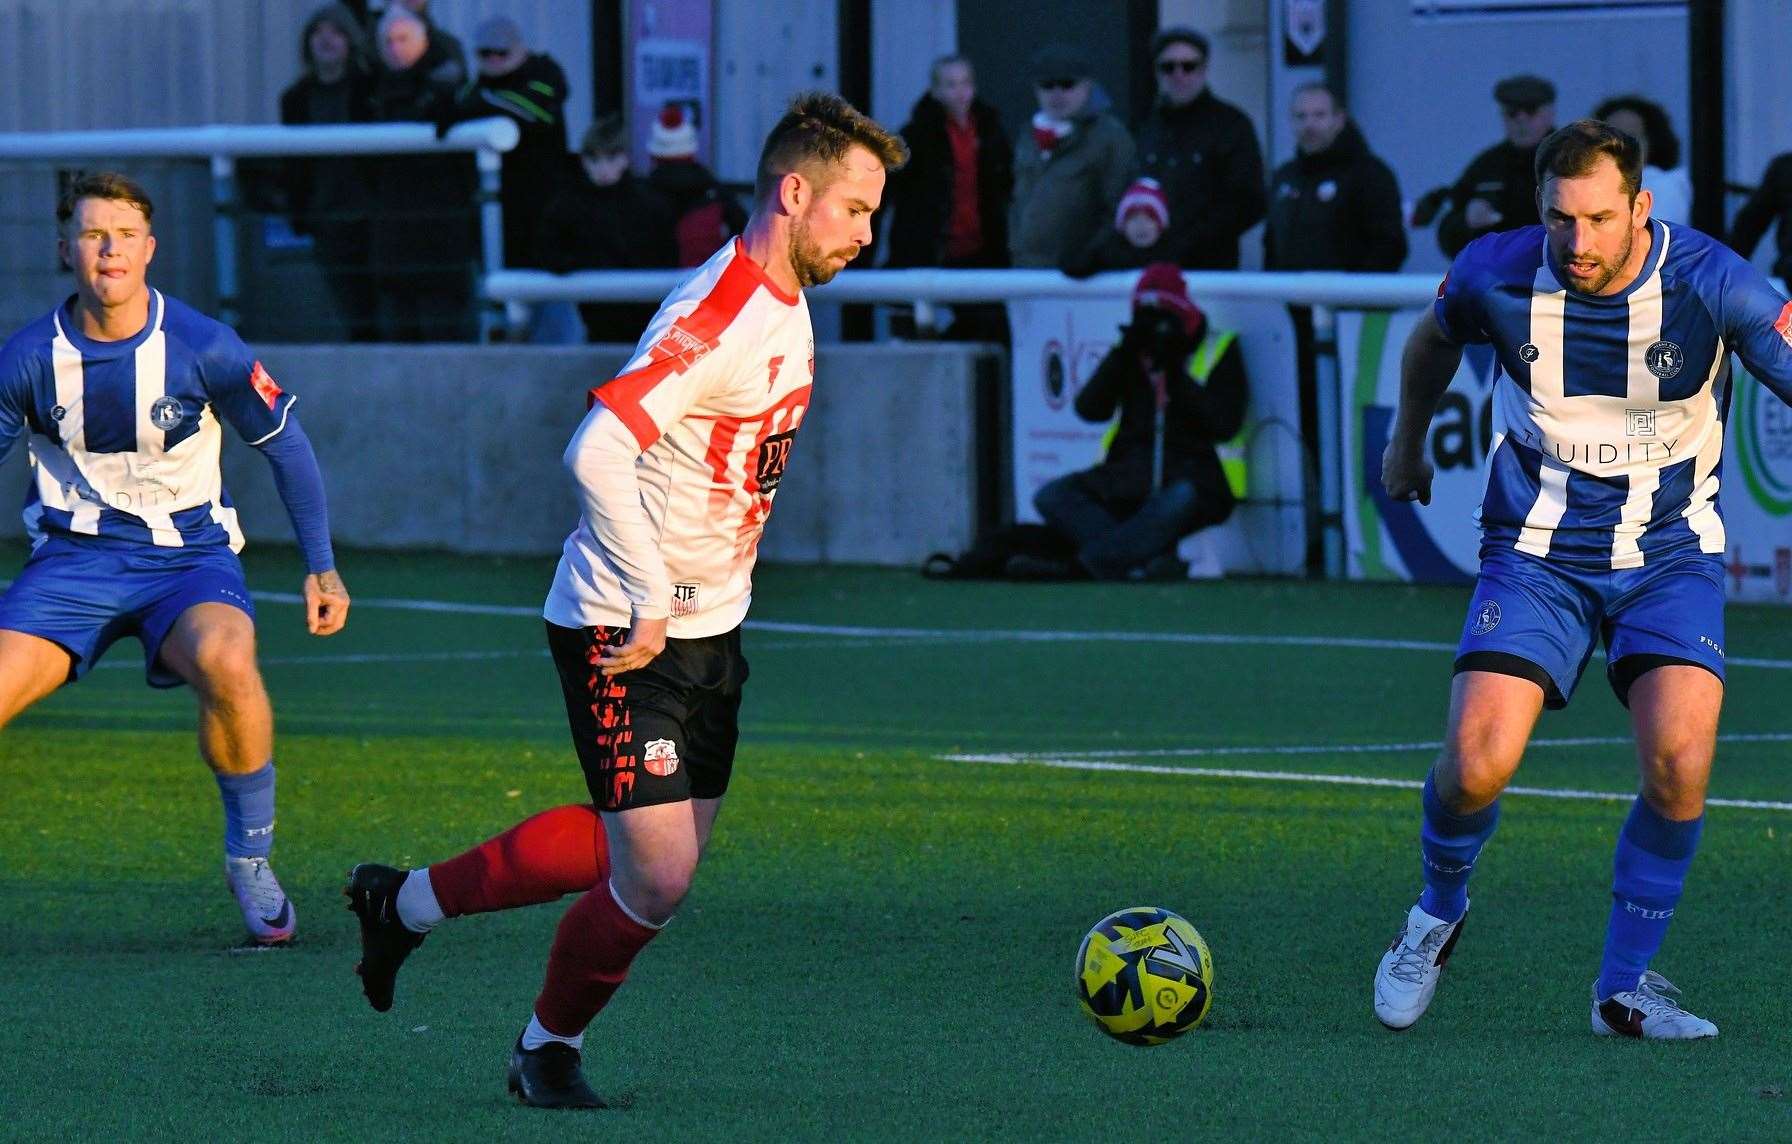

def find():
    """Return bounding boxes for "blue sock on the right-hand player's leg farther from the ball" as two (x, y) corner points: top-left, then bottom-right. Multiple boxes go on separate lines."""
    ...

(1595, 798), (1704, 1001)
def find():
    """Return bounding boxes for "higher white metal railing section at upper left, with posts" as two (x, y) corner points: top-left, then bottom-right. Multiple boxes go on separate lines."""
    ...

(0, 117), (520, 337)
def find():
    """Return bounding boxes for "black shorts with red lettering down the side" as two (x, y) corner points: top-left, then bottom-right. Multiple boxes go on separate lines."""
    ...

(548, 624), (747, 810)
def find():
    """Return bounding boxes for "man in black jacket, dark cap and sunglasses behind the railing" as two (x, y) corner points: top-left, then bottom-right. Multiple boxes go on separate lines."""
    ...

(1138, 27), (1263, 271)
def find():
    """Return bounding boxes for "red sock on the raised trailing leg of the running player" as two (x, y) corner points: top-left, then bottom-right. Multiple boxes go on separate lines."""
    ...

(430, 805), (609, 918)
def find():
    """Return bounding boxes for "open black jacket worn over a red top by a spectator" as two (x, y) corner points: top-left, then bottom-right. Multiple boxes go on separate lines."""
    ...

(887, 95), (1014, 267)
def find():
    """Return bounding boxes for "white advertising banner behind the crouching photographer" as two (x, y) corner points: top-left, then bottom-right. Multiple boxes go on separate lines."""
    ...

(1007, 298), (1308, 576)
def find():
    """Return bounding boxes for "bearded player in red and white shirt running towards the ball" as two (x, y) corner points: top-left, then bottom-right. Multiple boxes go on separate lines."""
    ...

(346, 93), (907, 1108)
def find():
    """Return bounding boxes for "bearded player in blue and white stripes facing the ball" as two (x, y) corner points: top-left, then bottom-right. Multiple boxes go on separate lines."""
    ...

(1374, 120), (1792, 1040)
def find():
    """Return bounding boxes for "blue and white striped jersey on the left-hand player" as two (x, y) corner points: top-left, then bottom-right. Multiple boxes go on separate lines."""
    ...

(0, 289), (296, 550)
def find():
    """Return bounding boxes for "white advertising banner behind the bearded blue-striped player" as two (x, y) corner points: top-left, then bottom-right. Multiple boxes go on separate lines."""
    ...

(1337, 310), (1792, 602)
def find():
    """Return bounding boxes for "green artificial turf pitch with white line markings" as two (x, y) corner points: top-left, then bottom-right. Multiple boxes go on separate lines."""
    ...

(0, 549), (1792, 1140)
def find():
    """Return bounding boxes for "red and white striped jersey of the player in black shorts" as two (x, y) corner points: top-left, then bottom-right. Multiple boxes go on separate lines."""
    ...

(543, 238), (815, 638)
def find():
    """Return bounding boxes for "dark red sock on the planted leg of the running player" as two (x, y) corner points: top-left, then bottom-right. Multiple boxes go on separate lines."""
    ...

(536, 880), (659, 1036)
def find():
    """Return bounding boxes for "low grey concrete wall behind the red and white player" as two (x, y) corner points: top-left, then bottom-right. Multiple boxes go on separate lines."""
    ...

(0, 344), (987, 565)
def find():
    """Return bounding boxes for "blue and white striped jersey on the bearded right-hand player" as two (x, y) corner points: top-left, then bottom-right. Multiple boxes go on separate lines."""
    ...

(1435, 221), (1792, 568)
